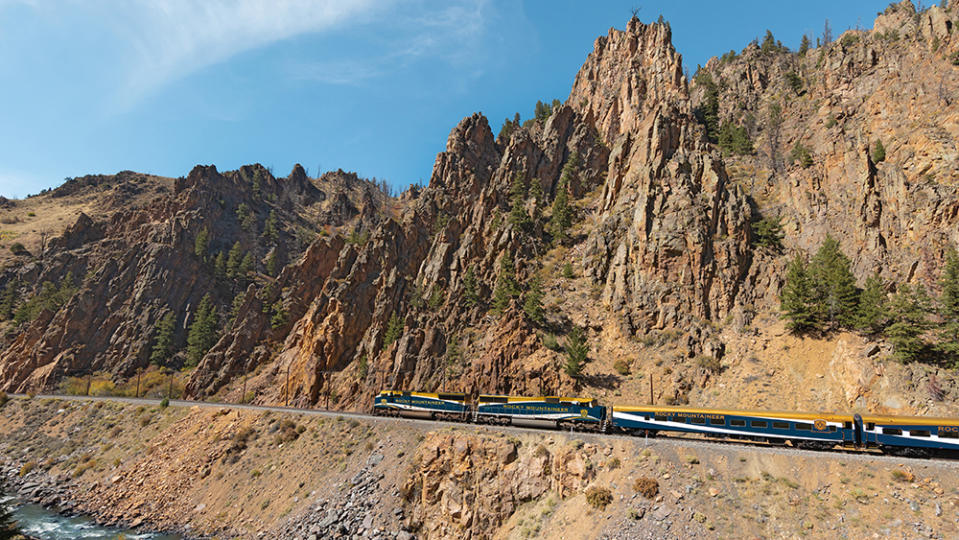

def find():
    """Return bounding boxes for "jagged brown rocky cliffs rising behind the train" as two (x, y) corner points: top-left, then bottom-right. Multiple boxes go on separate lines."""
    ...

(0, 2), (959, 413)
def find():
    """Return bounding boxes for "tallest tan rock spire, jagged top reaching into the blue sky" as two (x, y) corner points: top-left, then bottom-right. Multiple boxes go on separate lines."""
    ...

(569, 19), (751, 332)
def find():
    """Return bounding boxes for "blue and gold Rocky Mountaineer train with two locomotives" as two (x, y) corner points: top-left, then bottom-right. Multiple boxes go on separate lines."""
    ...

(373, 390), (959, 456)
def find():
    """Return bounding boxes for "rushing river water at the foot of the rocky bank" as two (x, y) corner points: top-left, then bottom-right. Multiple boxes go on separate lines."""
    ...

(0, 498), (180, 540)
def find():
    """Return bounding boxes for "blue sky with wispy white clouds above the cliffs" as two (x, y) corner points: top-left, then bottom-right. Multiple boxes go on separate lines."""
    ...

(0, 0), (887, 197)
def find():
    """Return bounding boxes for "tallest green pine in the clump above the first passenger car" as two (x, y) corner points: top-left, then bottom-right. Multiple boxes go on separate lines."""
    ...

(809, 234), (859, 328)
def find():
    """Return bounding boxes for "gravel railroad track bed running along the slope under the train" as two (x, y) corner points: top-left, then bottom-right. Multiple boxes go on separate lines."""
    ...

(8, 394), (959, 471)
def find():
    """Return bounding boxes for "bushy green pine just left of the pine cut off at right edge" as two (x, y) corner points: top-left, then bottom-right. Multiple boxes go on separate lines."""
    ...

(885, 284), (931, 362)
